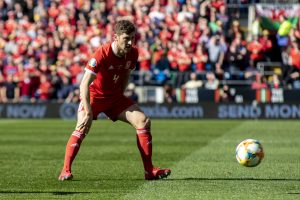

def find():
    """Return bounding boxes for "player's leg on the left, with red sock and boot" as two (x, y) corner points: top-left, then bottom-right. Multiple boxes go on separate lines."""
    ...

(58, 110), (92, 181)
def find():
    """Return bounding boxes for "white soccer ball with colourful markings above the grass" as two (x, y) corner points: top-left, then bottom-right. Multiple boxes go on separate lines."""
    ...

(235, 139), (264, 167)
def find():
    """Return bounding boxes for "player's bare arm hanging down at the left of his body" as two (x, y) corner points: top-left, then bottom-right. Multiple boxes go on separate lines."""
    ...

(80, 70), (96, 116)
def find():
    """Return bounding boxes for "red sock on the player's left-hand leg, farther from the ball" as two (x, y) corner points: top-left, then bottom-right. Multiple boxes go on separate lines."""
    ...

(64, 131), (85, 172)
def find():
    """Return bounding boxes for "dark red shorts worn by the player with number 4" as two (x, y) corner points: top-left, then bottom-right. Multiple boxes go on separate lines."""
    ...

(78, 95), (135, 121)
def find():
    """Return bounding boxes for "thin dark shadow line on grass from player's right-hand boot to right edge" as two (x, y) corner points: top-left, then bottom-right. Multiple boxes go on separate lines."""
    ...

(166, 177), (300, 181)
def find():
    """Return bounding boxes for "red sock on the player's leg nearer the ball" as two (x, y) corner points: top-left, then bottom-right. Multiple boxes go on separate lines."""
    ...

(136, 128), (153, 173)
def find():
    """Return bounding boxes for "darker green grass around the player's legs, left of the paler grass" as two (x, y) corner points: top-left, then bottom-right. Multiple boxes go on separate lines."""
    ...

(0, 120), (237, 199)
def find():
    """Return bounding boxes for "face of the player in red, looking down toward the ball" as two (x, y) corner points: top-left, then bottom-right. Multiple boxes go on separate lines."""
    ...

(116, 32), (135, 55)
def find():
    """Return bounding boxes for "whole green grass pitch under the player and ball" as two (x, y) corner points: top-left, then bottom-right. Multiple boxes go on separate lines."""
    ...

(0, 119), (300, 200)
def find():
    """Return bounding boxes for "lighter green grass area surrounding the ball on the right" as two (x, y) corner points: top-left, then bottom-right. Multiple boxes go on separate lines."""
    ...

(120, 121), (300, 200)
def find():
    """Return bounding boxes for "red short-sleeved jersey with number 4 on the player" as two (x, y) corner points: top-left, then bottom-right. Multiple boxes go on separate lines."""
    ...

(85, 42), (138, 99)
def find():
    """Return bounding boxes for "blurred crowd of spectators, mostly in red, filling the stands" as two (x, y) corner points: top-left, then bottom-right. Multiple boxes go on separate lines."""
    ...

(0, 0), (300, 102)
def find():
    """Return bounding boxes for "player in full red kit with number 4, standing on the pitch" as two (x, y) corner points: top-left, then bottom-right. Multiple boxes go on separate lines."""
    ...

(58, 20), (171, 181)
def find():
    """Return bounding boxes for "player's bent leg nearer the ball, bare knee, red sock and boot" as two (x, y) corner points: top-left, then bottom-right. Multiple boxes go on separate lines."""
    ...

(118, 105), (171, 180)
